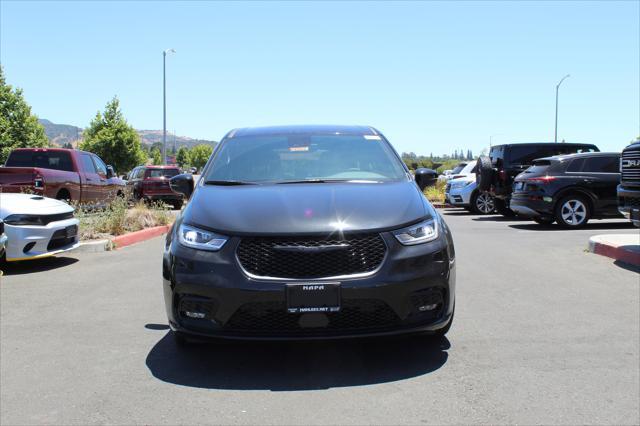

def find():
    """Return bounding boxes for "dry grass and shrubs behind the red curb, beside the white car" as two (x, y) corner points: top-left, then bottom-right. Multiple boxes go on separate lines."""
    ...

(76, 198), (173, 240)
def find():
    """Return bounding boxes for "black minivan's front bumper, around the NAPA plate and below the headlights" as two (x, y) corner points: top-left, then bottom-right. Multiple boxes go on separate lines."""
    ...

(163, 226), (455, 340)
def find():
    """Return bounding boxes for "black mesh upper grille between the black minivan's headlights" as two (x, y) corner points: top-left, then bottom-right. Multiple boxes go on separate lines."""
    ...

(237, 234), (387, 279)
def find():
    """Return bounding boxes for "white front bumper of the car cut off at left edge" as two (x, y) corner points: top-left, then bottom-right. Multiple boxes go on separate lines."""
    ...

(4, 218), (80, 262)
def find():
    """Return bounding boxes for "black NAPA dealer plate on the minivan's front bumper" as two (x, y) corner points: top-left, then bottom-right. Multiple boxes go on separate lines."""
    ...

(285, 282), (342, 314)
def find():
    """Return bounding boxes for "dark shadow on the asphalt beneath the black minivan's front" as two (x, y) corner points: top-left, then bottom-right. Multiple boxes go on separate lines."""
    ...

(146, 332), (451, 391)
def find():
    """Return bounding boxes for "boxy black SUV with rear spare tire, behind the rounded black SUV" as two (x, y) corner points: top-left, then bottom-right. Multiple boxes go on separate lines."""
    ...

(476, 143), (600, 216)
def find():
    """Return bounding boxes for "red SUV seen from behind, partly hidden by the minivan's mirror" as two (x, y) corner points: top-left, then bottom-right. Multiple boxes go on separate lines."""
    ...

(127, 166), (184, 210)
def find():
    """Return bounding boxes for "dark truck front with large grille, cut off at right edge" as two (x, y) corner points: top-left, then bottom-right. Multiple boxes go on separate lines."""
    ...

(618, 141), (640, 227)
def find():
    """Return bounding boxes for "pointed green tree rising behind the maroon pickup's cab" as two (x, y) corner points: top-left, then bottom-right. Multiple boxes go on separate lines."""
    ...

(80, 96), (146, 172)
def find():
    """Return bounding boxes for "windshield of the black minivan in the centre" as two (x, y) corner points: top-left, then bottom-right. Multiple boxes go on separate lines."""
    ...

(205, 134), (406, 183)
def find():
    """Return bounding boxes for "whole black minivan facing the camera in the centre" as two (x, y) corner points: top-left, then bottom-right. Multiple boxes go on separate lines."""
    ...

(163, 126), (455, 343)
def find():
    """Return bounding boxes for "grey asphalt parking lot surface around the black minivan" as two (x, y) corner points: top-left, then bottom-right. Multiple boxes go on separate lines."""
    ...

(0, 210), (640, 424)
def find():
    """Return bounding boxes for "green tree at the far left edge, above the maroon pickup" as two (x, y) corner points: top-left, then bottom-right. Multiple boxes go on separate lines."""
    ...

(0, 66), (49, 163)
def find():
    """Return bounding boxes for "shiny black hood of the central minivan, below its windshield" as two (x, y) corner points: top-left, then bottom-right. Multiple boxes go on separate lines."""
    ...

(183, 181), (430, 235)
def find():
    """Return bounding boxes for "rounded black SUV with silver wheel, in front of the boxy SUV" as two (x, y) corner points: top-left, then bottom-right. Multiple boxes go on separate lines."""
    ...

(510, 152), (620, 228)
